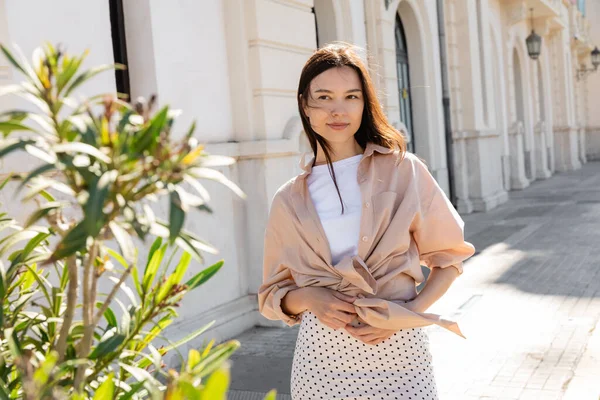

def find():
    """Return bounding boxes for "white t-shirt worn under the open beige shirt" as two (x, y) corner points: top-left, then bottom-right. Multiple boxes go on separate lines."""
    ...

(308, 154), (363, 264)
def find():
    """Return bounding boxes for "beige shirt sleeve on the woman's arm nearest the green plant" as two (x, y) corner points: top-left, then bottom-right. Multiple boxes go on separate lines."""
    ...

(258, 193), (300, 326)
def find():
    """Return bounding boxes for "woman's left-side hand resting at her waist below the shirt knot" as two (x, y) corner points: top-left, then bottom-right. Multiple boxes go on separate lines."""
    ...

(302, 287), (356, 330)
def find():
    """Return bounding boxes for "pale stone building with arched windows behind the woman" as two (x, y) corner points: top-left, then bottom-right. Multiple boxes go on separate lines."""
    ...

(0, 0), (600, 350)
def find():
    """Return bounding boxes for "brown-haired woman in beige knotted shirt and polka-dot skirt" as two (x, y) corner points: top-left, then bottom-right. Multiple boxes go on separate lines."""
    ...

(258, 44), (474, 400)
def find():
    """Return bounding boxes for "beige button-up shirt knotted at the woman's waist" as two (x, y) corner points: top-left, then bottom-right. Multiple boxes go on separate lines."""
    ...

(258, 143), (475, 336)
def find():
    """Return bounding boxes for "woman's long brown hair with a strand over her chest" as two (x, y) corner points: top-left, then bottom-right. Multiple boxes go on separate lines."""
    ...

(297, 42), (406, 213)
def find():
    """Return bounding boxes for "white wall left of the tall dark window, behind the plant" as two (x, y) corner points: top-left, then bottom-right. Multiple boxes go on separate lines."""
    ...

(0, 0), (116, 223)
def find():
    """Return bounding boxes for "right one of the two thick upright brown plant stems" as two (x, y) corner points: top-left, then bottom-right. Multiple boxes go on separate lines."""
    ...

(74, 240), (98, 392)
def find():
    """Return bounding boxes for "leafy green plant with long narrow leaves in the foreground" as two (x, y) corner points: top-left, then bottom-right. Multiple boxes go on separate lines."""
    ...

(0, 44), (270, 399)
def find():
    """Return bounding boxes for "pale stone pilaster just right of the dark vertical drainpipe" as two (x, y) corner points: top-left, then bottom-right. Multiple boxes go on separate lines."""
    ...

(445, 0), (508, 211)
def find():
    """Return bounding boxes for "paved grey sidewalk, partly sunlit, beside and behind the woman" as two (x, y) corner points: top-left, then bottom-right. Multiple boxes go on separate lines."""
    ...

(229, 163), (600, 400)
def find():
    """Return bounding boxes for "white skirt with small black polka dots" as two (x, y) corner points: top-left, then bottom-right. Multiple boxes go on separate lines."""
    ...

(291, 312), (438, 400)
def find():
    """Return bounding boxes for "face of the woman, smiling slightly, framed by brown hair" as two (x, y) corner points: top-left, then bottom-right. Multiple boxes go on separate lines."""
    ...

(304, 66), (365, 145)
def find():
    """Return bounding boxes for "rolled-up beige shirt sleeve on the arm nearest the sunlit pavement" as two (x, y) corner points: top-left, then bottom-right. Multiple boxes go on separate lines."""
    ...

(412, 161), (475, 274)
